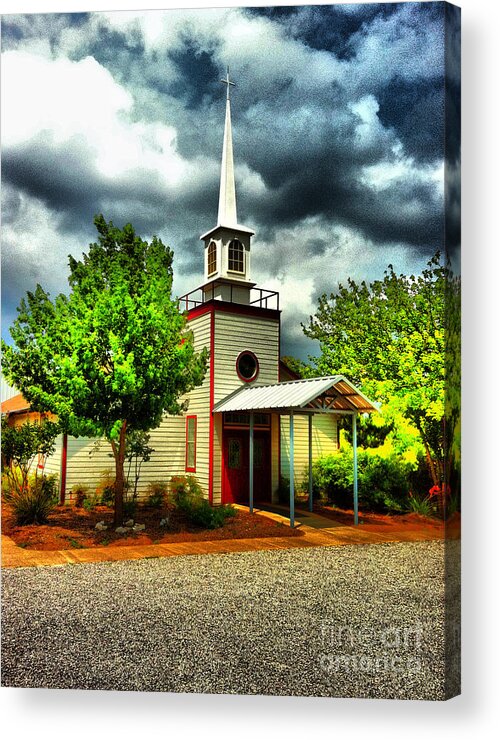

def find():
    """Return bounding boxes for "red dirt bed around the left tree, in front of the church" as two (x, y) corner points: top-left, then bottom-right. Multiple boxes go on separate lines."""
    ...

(2, 502), (303, 550)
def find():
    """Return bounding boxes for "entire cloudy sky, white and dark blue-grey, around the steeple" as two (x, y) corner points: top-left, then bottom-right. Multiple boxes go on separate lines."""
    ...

(1, 3), (459, 358)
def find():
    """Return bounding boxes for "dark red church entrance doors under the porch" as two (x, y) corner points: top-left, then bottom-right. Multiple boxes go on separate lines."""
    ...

(222, 428), (271, 505)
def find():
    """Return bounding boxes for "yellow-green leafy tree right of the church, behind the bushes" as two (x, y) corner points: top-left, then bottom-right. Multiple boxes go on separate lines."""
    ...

(304, 253), (459, 484)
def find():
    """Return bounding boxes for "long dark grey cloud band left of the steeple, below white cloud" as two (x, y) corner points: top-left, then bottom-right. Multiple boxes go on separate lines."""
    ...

(2, 128), (216, 240)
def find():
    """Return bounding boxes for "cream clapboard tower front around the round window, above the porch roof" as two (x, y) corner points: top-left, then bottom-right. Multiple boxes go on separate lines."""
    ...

(214, 312), (279, 403)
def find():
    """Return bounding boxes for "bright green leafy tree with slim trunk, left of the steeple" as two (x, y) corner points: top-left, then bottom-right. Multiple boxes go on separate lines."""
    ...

(2, 215), (207, 524)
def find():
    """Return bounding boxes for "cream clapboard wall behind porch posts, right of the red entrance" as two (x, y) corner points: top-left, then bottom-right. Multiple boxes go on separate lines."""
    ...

(281, 414), (338, 490)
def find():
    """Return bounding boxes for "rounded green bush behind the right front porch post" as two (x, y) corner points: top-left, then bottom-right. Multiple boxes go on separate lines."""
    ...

(313, 449), (413, 512)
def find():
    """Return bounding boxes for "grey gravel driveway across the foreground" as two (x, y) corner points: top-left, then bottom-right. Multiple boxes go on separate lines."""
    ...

(2, 542), (459, 699)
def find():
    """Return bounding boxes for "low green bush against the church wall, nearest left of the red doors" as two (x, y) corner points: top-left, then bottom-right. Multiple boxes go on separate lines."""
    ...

(170, 475), (236, 529)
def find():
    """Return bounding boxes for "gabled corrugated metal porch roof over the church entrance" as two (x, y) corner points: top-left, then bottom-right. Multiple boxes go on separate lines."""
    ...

(214, 375), (378, 413)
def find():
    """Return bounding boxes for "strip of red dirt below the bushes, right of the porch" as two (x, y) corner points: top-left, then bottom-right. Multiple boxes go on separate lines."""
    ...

(314, 506), (460, 539)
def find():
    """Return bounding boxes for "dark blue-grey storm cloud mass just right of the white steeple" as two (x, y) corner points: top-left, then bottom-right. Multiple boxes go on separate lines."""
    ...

(243, 101), (442, 251)
